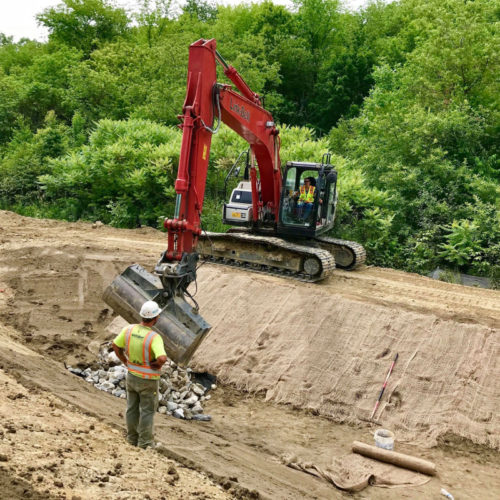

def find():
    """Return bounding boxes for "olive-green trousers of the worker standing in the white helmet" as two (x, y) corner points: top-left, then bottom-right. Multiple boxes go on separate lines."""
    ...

(126, 373), (159, 448)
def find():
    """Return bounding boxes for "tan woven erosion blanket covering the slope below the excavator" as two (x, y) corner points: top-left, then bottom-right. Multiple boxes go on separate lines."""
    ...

(193, 267), (500, 448)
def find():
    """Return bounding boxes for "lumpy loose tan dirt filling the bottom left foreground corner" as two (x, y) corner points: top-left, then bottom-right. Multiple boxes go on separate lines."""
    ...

(0, 364), (229, 500)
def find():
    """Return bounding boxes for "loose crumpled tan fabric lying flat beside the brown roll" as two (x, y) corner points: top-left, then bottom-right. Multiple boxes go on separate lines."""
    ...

(285, 453), (430, 492)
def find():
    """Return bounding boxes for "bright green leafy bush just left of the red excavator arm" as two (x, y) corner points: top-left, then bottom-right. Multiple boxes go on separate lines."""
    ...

(40, 120), (181, 227)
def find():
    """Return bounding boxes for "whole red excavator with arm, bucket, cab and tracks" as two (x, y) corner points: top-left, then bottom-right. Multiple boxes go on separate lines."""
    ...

(104, 39), (365, 364)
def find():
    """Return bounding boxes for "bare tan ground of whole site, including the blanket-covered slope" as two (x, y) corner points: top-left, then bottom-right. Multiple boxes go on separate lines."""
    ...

(0, 211), (500, 499)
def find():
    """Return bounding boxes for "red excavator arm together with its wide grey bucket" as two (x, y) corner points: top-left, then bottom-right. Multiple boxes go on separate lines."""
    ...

(103, 40), (281, 364)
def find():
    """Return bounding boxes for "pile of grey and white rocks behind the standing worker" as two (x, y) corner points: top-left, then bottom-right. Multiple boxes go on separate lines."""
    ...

(68, 353), (216, 420)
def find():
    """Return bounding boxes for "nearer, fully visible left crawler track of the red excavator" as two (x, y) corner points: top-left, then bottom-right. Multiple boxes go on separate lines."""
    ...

(197, 232), (335, 282)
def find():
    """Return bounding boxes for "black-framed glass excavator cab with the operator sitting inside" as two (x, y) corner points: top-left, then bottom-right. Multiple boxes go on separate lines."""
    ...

(278, 155), (337, 238)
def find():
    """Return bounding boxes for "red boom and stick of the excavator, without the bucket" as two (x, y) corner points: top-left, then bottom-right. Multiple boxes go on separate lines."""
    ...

(164, 39), (281, 262)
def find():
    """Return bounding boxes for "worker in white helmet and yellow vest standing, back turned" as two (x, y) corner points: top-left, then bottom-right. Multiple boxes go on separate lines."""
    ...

(113, 300), (167, 448)
